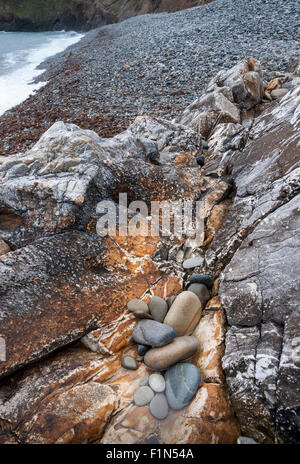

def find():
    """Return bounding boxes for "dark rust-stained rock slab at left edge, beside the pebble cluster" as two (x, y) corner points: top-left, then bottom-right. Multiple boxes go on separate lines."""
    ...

(0, 232), (161, 375)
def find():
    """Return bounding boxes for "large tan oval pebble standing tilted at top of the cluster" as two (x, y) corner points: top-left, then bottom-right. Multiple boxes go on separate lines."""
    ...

(164, 291), (202, 337)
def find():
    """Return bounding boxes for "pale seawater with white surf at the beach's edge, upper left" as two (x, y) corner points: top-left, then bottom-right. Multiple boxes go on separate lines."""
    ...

(0, 31), (83, 115)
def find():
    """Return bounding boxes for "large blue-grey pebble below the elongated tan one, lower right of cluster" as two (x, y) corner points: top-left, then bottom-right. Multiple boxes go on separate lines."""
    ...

(166, 363), (202, 410)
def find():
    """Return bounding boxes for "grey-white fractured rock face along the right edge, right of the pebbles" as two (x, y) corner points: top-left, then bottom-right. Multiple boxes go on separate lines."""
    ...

(207, 74), (300, 443)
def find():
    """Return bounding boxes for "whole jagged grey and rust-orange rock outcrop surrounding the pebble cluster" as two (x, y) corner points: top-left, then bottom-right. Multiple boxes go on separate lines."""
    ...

(0, 59), (300, 444)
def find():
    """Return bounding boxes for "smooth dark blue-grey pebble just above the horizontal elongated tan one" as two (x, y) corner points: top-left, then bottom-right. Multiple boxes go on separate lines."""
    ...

(132, 319), (176, 347)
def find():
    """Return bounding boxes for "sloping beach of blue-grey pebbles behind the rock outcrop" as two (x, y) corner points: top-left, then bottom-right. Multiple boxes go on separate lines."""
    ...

(0, 0), (299, 154)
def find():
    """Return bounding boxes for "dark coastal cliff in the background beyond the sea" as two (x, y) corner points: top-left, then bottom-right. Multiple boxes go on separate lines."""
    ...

(0, 0), (208, 31)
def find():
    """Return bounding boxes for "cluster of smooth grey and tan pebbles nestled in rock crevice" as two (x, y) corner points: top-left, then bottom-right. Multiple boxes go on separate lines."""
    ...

(121, 272), (213, 420)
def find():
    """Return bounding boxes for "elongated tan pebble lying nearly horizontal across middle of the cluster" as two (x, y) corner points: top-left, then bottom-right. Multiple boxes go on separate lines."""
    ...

(144, 336), (200, 371)
